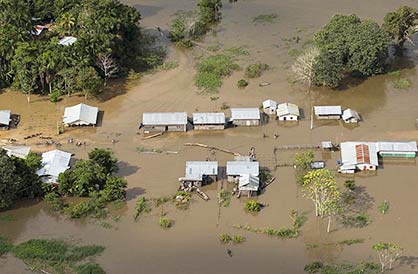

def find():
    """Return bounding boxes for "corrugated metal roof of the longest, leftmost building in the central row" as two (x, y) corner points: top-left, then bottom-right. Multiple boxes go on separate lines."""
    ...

(142, 112), (187, 125)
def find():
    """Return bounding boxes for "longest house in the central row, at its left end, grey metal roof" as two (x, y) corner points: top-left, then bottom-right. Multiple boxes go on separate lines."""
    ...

(142, 112), (187, 132)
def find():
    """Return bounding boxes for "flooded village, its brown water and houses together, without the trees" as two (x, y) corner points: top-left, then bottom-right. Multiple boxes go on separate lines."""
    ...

(0, 0), (418, 274)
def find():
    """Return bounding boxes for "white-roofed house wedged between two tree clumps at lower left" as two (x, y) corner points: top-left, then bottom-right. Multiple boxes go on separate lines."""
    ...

(36, 150), (71, 183)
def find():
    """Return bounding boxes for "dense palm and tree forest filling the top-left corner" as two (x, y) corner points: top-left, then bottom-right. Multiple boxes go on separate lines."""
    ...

(0, 0), (158, 96)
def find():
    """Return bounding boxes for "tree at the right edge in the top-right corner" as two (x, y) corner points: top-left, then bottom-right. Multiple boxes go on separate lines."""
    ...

(383, 6), (418, 48)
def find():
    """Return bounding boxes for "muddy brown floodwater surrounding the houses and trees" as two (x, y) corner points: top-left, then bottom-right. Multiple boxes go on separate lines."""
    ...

(0, 0), (418, 274)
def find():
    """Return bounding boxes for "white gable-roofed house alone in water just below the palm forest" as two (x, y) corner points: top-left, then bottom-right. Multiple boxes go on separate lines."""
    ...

(63, 103), (99, 125)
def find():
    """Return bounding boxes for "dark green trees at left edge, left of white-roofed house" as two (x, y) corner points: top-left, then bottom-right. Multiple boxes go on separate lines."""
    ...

(0, 149), (43, 211)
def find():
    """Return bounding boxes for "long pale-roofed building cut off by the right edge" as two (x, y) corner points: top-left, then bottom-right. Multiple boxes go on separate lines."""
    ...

(376, 141), (417, 158)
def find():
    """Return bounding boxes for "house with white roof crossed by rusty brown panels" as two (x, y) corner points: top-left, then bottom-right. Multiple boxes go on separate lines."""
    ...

(338, 142), (379, 173)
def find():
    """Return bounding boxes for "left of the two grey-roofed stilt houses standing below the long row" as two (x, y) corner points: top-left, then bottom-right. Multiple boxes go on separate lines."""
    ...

(179, 161), (218, 187)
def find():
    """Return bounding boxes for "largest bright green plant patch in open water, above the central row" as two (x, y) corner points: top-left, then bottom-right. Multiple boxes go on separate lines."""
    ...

(195, 54), (239, 92)
